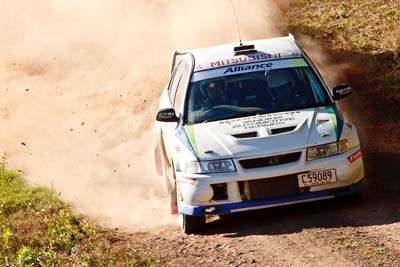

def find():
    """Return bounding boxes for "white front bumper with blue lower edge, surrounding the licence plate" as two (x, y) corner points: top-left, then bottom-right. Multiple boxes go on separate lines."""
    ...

(177, 147), (364, 215)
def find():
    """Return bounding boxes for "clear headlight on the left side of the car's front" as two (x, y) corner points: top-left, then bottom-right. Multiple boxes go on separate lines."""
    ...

(186, 159), (236, 173)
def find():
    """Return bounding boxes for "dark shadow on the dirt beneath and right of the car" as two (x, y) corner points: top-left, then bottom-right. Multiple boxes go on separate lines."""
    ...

(199, 153), (400, 238)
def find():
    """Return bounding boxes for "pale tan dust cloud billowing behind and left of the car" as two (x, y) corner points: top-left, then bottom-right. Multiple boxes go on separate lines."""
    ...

(0, 0), (288, 229)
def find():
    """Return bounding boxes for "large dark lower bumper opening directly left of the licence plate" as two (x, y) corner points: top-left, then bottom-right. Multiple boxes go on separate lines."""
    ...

(239, 174), (302, 200)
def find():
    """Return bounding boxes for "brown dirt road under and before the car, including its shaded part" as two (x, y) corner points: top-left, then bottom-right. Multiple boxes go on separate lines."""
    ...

(122, 153), (400, 266)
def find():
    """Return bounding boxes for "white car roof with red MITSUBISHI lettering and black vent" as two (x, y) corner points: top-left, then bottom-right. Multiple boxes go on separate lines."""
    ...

(185, 35), (301, 71)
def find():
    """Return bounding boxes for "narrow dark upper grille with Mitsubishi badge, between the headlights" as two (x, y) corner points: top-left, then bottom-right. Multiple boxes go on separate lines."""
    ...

(239, 152), (301, 169)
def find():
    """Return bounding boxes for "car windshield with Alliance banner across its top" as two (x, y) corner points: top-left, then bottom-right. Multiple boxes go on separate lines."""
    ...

(186, 60), (331, 124)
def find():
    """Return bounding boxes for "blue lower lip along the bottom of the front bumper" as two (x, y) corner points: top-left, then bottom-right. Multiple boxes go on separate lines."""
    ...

(178, 179), (365, 216)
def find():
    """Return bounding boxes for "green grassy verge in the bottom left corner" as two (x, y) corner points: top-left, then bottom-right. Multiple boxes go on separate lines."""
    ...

(0, 154), (162, 266)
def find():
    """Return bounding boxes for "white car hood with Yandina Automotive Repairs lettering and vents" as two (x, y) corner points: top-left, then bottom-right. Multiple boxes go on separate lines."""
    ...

(185, 106), (342, 160)
